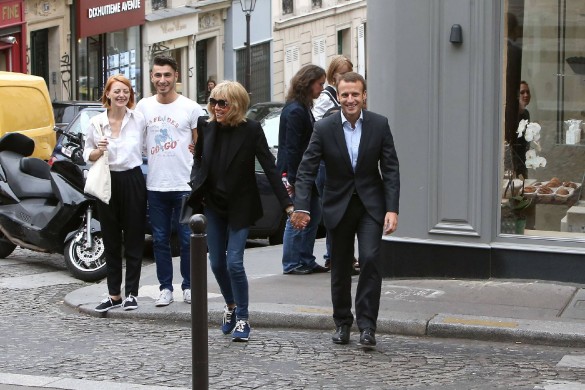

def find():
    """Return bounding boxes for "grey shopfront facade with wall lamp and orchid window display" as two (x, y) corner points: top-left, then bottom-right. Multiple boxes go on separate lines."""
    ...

(368, 0), (585, 283)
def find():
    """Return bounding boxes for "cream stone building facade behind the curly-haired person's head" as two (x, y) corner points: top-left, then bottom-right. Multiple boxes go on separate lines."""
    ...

(272, 0), (362, 101)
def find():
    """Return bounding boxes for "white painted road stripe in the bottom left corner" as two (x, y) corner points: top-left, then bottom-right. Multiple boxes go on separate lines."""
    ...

(0, 373), (188, 390)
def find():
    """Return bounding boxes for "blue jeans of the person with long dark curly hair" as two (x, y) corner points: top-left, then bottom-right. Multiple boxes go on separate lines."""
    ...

(282, 194), (321, 273)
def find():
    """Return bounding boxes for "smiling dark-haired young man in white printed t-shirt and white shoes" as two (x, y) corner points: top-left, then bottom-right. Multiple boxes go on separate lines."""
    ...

(136, 55), (203, 306)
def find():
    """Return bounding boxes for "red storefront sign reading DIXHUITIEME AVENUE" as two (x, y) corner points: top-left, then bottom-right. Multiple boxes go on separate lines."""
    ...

(75, 0), (145, 38)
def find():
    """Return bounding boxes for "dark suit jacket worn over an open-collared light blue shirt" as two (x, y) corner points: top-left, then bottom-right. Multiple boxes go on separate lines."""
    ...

(295, 111), (400, 229)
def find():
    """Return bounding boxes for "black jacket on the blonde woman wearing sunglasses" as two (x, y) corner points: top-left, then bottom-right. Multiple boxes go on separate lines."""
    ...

(189, 119), (292, 227)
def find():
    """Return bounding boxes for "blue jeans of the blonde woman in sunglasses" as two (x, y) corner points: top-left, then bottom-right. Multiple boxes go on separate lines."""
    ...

(204, 207), (250, 320)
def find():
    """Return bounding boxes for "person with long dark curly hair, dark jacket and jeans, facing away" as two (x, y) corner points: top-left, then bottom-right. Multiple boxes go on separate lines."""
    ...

(276, 65), (329, 275)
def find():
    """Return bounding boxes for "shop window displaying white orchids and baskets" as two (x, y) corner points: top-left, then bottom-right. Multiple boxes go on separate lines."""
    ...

(500, 0), (585, 238)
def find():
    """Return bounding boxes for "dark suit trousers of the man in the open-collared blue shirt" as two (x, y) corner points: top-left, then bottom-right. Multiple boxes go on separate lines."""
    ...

(328, 195), (383, 331)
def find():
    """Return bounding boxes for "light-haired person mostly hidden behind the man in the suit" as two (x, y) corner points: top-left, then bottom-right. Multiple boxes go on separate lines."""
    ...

(311, 55), (360, 275)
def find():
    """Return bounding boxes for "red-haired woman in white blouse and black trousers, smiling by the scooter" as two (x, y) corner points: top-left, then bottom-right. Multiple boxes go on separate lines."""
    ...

(83, 75), (146, 312)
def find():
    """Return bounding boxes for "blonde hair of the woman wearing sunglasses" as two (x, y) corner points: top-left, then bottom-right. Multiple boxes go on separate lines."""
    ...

(207, 80), (250, 126)
